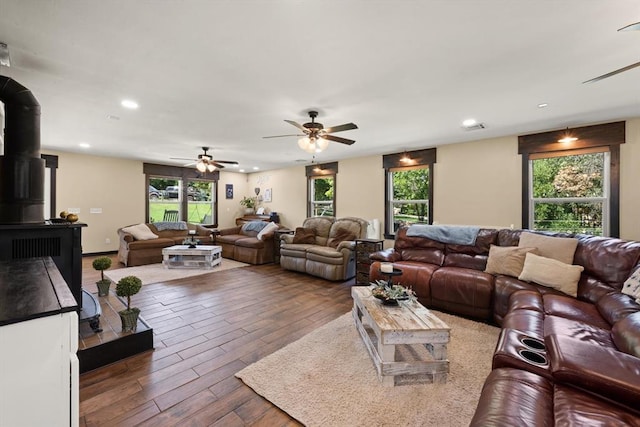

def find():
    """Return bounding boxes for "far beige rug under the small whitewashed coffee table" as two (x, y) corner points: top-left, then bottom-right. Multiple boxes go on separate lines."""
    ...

(104, 258), (250, 285)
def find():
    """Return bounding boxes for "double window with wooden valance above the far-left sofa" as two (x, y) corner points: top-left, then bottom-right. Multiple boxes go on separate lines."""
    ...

(144, 163), (219, 226)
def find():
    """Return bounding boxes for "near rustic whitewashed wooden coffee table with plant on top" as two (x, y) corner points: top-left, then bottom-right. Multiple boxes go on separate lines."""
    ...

(351, 286), (449, 386)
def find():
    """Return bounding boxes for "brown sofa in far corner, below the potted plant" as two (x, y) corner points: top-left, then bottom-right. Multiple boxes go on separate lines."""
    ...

(215, 221), (280, 264)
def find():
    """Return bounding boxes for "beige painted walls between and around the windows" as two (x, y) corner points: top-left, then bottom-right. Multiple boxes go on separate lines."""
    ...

(52, 118), (640, 253)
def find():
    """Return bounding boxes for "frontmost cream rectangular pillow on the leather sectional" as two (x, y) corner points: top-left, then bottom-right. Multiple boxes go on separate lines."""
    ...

(518, 252), (584, 297)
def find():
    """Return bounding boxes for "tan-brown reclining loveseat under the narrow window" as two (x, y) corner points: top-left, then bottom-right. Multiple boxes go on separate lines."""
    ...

(280, 216), (369, 281)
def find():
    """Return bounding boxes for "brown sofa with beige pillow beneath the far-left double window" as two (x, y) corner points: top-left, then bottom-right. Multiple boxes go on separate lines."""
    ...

(118, 221), (211, 267)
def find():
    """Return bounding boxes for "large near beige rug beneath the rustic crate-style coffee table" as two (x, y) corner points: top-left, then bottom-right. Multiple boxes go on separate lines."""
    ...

(236, 312), (500, 427)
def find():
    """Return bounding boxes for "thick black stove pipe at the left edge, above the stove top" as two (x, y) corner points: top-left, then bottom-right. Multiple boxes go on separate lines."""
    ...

(0, 76), (45, 224)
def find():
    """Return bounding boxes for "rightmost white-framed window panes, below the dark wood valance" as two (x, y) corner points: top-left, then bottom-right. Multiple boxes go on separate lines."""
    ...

(529, 152), (610, 236)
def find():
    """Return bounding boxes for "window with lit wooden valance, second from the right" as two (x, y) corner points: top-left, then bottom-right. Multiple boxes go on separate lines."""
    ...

(382, 149), (436, 239)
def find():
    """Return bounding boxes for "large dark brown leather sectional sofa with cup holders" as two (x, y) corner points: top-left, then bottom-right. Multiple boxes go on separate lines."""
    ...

(370, 228), (640, 426)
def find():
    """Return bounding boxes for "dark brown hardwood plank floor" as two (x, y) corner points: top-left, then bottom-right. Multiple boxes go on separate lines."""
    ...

(80, 256), (354, 426)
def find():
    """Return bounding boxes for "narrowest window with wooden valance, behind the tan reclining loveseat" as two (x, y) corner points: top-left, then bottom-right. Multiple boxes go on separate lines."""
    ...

(306, 163), (338, 216)
